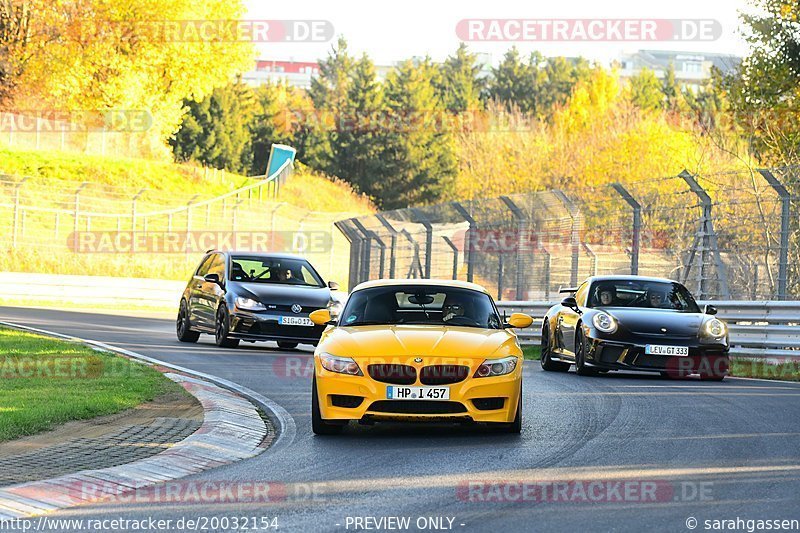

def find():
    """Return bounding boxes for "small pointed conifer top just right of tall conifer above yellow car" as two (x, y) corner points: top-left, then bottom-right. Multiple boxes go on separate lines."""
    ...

(436, 43), (486, 113)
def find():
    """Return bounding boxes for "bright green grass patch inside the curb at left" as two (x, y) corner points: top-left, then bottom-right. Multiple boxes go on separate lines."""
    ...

(0, 328), (182, 442)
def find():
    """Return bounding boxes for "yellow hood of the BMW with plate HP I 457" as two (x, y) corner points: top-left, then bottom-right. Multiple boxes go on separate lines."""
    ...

(320, 325), (516, 359)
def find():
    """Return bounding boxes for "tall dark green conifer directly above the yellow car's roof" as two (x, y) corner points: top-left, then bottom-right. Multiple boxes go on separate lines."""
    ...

(382, 58), (456, 209)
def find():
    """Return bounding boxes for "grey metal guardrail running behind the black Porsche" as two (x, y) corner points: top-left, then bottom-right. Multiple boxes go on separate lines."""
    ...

(497, 301), (800, 357)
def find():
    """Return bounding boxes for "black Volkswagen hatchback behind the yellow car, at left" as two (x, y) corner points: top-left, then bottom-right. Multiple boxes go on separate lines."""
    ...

(176, 251), (342, 349)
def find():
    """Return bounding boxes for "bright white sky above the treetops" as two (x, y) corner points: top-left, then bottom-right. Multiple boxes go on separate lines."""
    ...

(245, 0), (747, 65)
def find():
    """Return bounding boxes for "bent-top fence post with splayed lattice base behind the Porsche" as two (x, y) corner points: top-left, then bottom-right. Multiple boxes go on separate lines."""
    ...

(678, 169), (730, 300)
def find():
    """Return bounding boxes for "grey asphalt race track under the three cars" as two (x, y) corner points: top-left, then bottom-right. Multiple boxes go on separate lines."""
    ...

(0, 308), (800, 532)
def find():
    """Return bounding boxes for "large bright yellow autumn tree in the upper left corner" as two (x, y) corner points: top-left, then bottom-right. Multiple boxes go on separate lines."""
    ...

(0, 0), (254, 155)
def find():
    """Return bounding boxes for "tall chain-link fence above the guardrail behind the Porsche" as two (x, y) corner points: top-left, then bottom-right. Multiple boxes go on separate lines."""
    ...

(336, 167), (800, 300)
